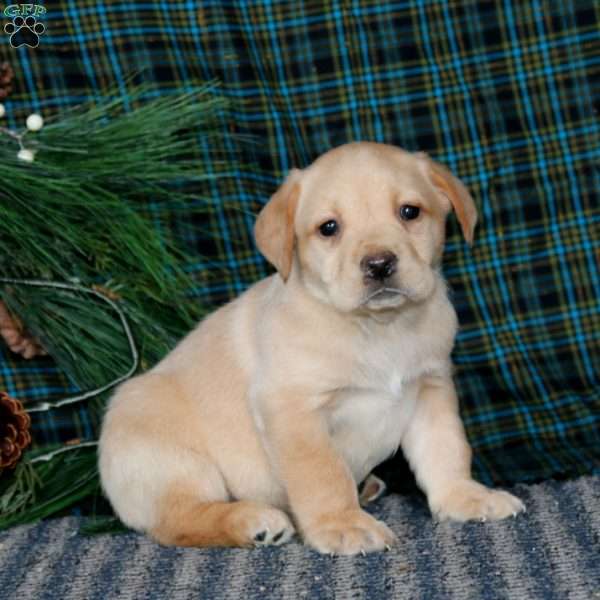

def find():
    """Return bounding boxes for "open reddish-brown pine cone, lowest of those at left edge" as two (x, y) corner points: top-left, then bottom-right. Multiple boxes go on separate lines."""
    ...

(0, 392), (31, 472)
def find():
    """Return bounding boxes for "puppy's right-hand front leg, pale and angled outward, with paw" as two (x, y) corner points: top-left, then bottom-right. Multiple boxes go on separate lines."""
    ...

(402, 377), (525, 521)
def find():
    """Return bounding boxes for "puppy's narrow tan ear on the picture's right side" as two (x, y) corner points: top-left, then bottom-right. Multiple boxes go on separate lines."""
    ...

(417, 152), (477, 245)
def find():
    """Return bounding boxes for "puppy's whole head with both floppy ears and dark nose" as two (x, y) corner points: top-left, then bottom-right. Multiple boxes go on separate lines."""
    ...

(255, 142), (477, 311)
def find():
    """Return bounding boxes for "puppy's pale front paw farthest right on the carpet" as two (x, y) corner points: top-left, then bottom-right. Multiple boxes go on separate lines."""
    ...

(430, 480), (525, 521)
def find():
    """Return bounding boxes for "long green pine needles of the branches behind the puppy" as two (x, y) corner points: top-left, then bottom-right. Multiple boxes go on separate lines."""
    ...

(0, 85), (230, 529)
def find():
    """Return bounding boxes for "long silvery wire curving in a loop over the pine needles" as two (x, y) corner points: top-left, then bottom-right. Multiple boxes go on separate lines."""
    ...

(0, 277), (140, 412)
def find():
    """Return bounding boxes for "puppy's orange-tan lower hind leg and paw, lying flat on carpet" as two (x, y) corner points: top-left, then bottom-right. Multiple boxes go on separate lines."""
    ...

(149, 484), (294, 546)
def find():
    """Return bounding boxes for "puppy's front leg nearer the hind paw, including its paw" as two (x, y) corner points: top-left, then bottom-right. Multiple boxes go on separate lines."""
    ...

(265, 393), (395, 554)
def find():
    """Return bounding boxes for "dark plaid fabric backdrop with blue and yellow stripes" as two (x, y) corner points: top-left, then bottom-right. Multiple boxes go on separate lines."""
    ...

(0, 0), (600, 483)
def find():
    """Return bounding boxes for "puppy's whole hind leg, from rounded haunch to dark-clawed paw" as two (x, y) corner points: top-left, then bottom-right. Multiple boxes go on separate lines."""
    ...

(99, 373), (294, 546)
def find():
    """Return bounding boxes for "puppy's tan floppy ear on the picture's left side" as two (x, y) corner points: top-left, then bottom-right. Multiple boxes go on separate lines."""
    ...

(254, 169), (301, 281)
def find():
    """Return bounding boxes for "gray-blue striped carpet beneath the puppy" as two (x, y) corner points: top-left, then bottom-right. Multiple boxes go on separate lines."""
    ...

(0, 477), (600, 600)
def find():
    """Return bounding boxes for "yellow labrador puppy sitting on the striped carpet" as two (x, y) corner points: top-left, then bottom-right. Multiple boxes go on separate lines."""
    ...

(100, 143), (524, 554)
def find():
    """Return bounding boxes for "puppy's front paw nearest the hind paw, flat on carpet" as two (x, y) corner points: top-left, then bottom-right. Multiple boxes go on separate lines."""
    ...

(304, 509), (396, 554)
